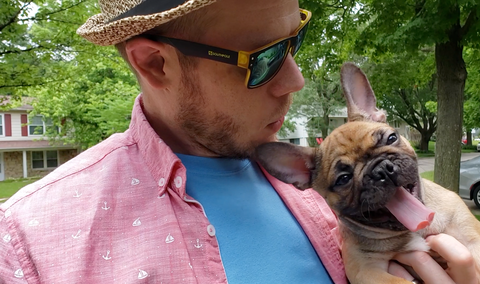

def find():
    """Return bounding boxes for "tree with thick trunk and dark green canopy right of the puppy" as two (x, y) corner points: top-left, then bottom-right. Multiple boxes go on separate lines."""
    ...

(350, 0), (480, 192)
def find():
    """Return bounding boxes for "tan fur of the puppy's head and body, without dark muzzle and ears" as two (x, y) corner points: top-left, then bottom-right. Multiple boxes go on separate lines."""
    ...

(320, 122), (480, 284)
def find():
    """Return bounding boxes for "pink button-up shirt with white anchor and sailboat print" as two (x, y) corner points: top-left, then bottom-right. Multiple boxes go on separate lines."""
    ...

(0, 96), (347, 284)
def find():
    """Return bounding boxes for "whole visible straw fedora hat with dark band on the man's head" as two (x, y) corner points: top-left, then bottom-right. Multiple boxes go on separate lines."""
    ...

(77, 0), (216, 45)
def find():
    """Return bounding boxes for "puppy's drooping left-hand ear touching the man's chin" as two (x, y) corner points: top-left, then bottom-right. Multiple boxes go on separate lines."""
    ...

(255, 142), (315, 189)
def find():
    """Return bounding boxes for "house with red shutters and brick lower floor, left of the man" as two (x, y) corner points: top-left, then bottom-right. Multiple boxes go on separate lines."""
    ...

(0, 97), (79, 181)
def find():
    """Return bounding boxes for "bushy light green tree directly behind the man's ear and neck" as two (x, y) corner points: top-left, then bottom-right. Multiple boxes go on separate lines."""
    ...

(30, 46), (139, 148)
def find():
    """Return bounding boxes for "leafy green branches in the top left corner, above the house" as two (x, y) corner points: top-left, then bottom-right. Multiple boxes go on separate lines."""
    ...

(0, 0), (95, 96)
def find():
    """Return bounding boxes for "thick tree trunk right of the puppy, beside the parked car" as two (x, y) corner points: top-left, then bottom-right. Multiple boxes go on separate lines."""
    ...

(434, 26), (467, 193)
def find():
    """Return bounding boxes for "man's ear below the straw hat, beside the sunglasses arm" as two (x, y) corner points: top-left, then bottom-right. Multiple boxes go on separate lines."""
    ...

(125, 37), (178, 88)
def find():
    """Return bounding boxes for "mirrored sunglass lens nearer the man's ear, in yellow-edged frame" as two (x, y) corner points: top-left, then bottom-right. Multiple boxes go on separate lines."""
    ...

(248, 41), (288, 87)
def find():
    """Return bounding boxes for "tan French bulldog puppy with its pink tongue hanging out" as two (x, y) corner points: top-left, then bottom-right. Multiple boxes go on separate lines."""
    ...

(256, 63), (480, 284)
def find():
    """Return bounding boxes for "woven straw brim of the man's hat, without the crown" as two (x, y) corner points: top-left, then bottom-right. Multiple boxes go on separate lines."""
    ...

(77, 0), (216, 45)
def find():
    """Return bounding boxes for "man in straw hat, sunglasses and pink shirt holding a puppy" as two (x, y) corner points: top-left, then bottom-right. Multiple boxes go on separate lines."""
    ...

(0, 0), (471, 283)
